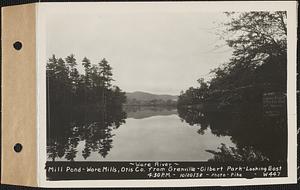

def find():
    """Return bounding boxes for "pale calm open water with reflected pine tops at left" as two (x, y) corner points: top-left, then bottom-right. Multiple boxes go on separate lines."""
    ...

(48, 108), (235, 161)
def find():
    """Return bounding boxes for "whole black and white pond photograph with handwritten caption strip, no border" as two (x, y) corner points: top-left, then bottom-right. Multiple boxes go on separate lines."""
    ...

(38, 3), (296, 186)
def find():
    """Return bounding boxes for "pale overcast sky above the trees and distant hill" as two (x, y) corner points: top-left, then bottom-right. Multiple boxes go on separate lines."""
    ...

(45, 4), (232, 95)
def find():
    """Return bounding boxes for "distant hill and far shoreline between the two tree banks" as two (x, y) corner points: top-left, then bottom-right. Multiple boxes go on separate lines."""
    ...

(126, 91), (178, 105)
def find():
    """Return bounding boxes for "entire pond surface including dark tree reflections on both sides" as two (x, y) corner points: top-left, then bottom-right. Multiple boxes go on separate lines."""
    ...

(47, 106), (287, 162)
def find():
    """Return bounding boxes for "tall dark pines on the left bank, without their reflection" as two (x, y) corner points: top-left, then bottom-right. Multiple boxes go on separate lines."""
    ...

(46, 54), (126, 132)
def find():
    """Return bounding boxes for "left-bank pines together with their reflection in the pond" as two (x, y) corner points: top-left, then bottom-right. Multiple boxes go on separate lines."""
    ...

(46, 54), (126, 161)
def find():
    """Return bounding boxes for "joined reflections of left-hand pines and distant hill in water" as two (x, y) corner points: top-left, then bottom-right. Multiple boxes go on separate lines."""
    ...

(47, 106), (177, 161)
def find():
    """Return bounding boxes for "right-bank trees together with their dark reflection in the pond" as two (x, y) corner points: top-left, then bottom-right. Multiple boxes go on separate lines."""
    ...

(177, 11), (287, 161)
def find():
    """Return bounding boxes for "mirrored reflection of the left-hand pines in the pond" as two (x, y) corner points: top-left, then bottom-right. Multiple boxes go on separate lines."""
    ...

(47, 107), (126, 161)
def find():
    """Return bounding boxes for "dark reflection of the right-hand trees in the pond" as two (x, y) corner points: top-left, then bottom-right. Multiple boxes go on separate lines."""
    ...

(178, 105), (287, 162)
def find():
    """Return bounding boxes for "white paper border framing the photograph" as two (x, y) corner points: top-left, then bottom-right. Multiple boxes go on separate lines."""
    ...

(36, 1), (297, 187)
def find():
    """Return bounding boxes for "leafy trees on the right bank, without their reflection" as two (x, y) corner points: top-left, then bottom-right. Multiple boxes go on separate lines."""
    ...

(178, 11), (287, 113)
